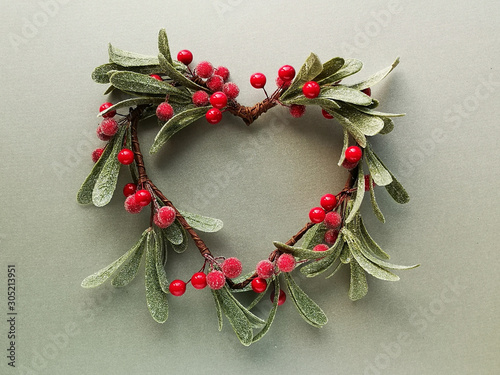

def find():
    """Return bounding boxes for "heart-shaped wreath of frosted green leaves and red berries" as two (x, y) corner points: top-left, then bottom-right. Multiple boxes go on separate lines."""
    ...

(77, 29), (418, 345)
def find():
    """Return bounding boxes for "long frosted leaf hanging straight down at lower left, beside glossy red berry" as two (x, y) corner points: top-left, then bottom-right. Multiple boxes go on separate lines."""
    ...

(146, 231), (168, 323)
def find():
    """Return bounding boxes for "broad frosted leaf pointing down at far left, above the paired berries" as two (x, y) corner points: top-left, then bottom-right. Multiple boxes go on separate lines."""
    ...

(92, 126), (127, 207)
